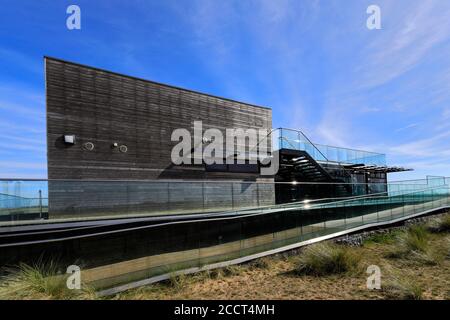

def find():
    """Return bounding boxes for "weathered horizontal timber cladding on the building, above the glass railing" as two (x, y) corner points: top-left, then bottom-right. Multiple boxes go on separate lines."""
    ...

(46, 58), (272, 180)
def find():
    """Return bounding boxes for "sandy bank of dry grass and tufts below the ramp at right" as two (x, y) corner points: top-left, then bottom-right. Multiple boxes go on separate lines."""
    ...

(113, 222), (450, 300)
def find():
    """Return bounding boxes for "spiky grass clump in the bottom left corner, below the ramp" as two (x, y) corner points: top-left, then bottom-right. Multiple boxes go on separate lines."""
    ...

(0, 261), (95, 300)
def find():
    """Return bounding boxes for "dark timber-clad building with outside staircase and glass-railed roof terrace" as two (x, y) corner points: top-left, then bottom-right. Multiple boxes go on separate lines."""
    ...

(45, 57), (412, 215)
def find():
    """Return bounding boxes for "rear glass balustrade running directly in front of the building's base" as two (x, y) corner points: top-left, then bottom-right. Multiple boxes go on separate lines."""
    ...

(0, 177), (449, 225)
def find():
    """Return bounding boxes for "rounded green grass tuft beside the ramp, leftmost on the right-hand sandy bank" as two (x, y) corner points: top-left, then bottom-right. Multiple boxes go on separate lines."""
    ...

(295, 243), (361, 276)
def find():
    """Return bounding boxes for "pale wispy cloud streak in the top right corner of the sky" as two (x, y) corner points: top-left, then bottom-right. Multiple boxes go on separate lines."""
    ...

(355, 0), (450, 88)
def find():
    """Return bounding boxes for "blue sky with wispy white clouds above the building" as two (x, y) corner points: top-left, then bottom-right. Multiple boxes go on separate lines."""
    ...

(0, 0), (450, 180)
